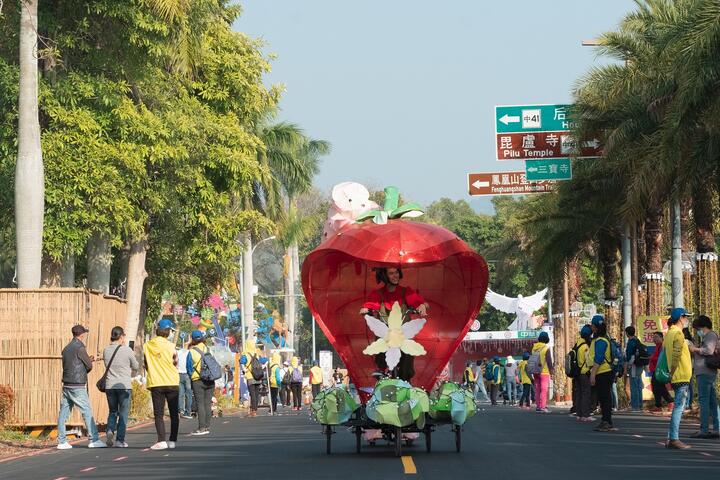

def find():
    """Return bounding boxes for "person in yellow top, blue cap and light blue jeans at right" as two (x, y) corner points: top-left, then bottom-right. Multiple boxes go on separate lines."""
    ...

(663, 307), (692, 450)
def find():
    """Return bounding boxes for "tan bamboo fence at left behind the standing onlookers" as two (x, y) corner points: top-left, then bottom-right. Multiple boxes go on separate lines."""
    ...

(0, 288), (127, 427)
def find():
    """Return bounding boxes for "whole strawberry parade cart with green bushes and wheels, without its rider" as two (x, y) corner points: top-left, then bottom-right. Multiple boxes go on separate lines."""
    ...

(302, 188), (488, 455)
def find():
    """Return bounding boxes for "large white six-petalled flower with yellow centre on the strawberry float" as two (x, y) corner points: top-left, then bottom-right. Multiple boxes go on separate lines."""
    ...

(363, 302), (427, 370)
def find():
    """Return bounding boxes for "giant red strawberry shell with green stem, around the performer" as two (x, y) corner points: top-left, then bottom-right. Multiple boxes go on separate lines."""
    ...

(302, 187), (488, 398)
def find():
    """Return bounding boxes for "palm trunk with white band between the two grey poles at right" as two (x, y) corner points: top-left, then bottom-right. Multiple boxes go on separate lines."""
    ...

(644, 208), (665, 315)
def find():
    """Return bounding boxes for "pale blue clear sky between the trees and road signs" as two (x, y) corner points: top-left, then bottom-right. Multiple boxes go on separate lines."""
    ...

(234, 0), (634, 213)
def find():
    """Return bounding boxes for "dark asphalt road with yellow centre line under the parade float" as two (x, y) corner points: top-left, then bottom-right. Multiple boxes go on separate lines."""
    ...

(0, 406), (720, 480)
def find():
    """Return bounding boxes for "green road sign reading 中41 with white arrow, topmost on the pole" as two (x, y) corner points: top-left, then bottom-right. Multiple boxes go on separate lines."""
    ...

(495, 105), (574, 133)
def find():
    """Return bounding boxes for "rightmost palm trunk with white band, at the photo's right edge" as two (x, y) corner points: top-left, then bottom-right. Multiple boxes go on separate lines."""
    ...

(693, 184), (720, 331)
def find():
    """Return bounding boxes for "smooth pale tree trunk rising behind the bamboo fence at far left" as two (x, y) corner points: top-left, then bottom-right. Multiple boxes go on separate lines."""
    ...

(15, 0), (45, 288)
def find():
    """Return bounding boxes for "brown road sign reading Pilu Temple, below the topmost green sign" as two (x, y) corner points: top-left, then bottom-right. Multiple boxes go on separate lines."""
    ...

(495, 131), (602, 160)
